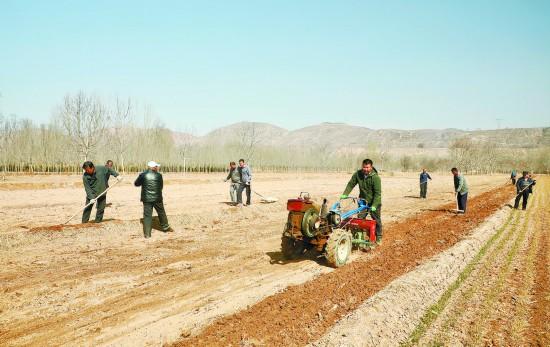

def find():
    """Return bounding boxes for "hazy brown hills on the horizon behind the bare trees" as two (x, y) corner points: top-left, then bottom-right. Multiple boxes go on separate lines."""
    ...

(173, 122), (550, 149)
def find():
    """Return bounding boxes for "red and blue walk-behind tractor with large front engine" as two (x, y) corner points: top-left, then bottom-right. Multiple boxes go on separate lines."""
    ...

(281, 192), (376, 267)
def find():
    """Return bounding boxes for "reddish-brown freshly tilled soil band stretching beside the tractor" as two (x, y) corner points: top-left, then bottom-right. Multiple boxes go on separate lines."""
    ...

(173, 185), (512, 346)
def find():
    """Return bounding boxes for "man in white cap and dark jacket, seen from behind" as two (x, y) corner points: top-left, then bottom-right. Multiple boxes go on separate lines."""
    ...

(134, 161), (174, 238)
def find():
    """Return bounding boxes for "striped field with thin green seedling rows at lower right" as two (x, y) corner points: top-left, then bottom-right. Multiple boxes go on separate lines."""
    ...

(418, 177), (550, 346)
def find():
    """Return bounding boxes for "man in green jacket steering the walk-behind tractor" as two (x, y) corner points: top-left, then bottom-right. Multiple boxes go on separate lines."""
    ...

(340, 159), (382, 245)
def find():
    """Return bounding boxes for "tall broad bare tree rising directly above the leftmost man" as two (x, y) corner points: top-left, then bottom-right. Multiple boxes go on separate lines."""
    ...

(60, 91), (107, 160)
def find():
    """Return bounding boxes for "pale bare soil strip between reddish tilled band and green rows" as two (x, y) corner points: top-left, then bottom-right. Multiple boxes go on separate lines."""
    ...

(311, 198), (511, 347)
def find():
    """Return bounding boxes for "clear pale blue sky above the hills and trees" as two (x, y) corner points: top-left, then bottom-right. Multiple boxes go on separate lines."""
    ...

(0, 0), (550, 134)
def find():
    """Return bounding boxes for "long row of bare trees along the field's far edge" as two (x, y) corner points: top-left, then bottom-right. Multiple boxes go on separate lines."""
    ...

(0, 92), (550, 176)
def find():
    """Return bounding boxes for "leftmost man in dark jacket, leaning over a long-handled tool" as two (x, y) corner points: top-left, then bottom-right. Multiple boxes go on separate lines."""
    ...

(82, 161), (122, 223)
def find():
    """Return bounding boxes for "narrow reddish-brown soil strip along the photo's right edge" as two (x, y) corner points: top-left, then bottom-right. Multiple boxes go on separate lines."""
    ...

(527, 186), (550, 346)
